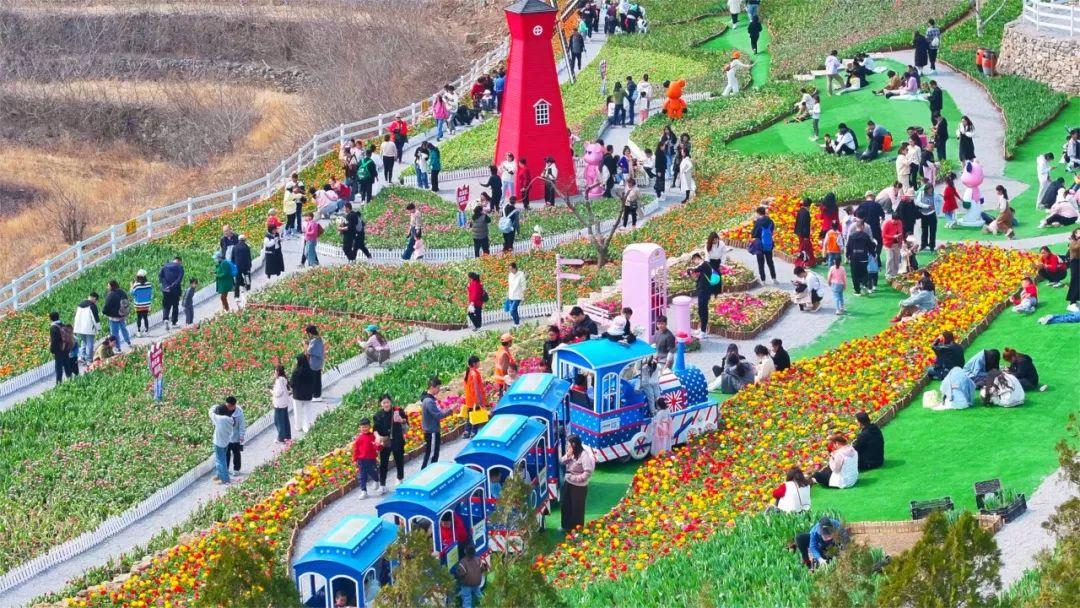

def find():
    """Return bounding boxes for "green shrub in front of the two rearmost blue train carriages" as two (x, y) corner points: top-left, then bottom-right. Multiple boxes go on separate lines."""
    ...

(373, 528), (457, 608)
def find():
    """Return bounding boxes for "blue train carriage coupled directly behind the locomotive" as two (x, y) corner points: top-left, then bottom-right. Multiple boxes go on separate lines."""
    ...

(492, 374), (570, 502)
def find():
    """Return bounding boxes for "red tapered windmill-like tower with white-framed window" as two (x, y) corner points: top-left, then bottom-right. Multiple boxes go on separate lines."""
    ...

(495, 0), (578, 200)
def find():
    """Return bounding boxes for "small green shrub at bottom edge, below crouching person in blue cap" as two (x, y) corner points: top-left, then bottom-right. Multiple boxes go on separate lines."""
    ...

(810, 544), (878, 608)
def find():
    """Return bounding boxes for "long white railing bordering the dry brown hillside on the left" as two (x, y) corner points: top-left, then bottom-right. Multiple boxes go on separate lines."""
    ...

(0, 39), (510, 311)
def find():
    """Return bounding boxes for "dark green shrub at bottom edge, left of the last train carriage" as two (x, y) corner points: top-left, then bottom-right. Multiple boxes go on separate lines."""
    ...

(194, 544), (301, 608)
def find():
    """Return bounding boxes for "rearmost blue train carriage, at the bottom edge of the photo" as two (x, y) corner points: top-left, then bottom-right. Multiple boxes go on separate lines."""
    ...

(293, 515), (397, 608)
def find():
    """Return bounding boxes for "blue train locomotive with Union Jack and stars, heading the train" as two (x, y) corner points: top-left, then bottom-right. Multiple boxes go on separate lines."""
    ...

(552, 338), (719, 462)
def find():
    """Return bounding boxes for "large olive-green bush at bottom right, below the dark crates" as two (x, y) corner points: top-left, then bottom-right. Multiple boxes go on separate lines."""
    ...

(878, 512), (1001, 608)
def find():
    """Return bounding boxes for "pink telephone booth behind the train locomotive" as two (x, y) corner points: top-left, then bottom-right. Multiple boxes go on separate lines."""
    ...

(622, 243), (667, 341)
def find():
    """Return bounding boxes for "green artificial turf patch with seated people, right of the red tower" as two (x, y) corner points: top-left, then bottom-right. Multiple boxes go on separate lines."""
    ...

(729, 59), (960, 163)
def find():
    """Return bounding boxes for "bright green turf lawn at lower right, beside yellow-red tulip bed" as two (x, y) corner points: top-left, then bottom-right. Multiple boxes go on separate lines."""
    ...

(813, 304), (1080, 522)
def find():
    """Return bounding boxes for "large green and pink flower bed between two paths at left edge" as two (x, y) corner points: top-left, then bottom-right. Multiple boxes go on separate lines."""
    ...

(0, 310), (403, 571)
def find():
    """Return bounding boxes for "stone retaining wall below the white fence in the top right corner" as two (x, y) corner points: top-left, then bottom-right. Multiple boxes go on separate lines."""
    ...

(998, 21), (1080, 95)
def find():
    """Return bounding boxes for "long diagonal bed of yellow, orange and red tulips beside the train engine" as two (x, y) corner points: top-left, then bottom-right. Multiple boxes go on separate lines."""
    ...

(539, 245), (1034, 586)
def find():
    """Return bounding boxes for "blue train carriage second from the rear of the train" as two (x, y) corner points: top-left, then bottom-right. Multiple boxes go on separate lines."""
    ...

(375, 462), (488, 568)
